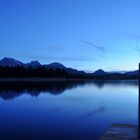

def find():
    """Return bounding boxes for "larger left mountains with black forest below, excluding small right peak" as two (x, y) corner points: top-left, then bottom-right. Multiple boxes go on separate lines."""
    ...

(0, 57), (90, 78)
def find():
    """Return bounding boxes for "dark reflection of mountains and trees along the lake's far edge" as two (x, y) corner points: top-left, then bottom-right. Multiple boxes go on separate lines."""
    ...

(0, 80), (138, 100)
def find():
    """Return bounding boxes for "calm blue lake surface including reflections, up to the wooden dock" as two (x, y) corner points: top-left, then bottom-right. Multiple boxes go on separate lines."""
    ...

(0, 81), (138, 140)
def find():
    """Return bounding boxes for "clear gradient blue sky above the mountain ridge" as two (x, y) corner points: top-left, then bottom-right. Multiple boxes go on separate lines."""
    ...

(0, 0), (140, 71)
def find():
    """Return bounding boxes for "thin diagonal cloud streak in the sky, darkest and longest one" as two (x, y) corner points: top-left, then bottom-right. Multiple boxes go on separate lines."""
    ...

(81, 40), (106, 52)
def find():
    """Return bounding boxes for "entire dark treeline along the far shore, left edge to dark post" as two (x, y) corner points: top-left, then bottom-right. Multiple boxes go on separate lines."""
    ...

(0, 66), (139, 80)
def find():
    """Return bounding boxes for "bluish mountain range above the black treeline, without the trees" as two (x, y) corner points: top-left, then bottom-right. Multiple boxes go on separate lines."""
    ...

(0, 57), (139, 77)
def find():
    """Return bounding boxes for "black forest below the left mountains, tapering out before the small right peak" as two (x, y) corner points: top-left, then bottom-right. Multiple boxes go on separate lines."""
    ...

(0, 66), (91, 79)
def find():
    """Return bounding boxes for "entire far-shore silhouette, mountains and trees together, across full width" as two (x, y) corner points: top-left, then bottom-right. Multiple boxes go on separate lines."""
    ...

(0, 57), (139, 79)
